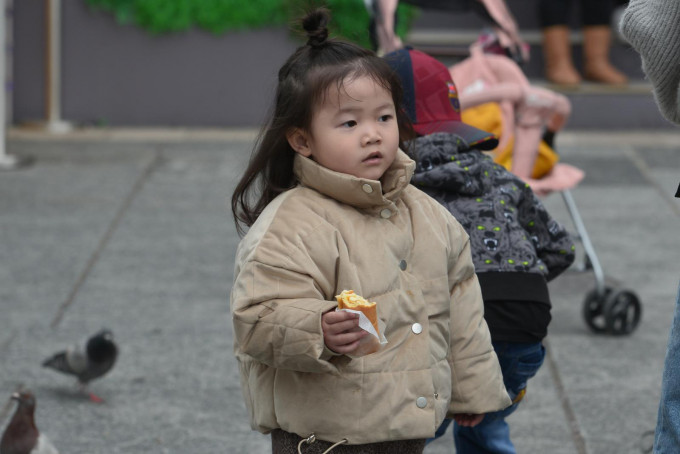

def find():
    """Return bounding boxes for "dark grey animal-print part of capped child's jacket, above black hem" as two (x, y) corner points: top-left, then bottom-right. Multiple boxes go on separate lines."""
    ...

(409, 133), (574, 281)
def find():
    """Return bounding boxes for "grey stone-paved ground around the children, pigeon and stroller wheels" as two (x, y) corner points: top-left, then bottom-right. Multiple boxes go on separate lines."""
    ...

(0, 125), (680, 454)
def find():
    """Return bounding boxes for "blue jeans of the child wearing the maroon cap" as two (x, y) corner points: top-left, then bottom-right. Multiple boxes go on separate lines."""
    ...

(428, 342), (545, 454)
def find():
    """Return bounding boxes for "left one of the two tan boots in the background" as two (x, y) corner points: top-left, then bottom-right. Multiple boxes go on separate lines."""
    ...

(543, 25), (581, 85)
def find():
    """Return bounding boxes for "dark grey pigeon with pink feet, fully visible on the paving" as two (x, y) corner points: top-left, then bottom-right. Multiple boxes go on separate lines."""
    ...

(42, 329), (118, 402)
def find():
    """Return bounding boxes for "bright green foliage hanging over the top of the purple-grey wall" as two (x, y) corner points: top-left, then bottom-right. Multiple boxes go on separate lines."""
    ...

(85, 0), (417, 47)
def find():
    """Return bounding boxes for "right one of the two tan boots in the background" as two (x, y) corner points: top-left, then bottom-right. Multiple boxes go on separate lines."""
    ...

(583, 25), (628, 85)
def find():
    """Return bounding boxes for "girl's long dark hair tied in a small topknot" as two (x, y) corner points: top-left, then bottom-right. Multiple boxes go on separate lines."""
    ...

(231, 8), (413, 234)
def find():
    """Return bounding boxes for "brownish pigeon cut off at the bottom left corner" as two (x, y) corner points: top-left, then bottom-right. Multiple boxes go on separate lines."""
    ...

(0, 390), (59, 454)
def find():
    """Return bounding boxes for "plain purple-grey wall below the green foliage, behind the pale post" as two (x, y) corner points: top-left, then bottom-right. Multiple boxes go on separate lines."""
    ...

(13, 0), (296, 127)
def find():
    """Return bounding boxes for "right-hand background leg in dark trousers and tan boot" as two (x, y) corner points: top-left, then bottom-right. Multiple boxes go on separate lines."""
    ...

(581, 0), (628, 85)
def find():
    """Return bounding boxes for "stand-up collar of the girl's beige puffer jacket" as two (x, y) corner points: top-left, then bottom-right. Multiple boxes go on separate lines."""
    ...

(293, 150), (415, 213)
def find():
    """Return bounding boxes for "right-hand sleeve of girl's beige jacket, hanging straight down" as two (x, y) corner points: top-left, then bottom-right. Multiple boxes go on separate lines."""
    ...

(449, 217), (511, 416)
